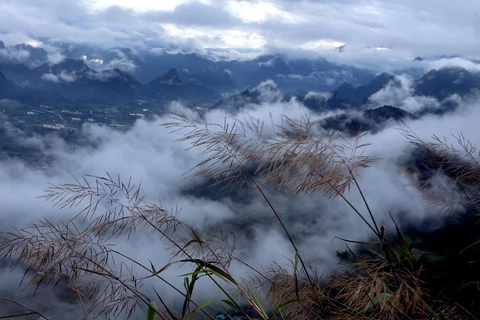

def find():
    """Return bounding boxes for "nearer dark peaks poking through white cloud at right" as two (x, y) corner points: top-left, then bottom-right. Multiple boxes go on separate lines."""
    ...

(211, 67), (480, 135)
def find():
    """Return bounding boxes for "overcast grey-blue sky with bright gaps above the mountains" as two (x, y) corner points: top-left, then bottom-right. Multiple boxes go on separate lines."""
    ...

(0, 0), (480, 63)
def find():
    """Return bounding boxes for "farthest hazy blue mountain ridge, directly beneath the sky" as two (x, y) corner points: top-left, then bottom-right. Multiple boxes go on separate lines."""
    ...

(56, 45), (375, 93)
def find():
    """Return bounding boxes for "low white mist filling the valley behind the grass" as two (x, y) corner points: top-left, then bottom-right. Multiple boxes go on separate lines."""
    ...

(0, 86), (480, 313)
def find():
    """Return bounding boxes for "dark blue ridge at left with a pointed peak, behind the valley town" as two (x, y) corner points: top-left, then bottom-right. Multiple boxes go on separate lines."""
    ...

(0, 59), (220, 103)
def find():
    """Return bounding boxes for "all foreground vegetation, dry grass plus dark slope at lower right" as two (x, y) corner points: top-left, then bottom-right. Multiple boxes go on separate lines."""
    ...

(1, 115), (480, 319)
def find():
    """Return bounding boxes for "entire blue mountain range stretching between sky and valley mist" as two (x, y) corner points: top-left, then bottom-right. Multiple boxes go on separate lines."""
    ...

(0, 41), (480, 133)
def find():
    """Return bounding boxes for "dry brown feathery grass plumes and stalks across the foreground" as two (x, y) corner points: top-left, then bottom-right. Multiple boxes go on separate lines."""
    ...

(0, 115), (480, 320)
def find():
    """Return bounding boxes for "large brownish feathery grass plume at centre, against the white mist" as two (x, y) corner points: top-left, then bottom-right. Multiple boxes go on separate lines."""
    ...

(166, 115), (374, 197)
